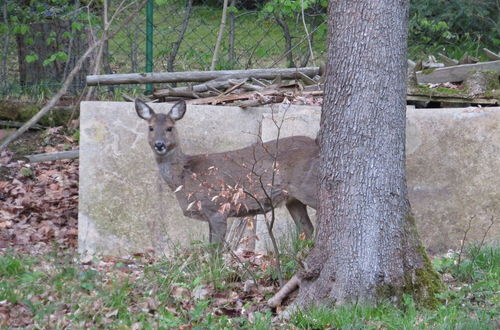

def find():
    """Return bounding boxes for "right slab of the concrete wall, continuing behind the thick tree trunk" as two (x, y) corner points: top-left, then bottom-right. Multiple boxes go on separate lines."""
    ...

(256, 107), (500, 254)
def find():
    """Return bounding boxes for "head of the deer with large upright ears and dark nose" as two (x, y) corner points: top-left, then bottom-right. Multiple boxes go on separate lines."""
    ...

(135, 99), (186, 156)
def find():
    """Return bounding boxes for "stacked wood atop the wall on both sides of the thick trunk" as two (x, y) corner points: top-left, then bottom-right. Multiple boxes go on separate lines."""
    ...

(87, 49), (500, 108)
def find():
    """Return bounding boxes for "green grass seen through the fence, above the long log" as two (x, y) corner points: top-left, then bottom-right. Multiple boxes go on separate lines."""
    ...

(110, 3), (326, 72)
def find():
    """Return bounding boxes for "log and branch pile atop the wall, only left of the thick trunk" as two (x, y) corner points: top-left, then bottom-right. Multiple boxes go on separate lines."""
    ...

(91, 67), (323, 108)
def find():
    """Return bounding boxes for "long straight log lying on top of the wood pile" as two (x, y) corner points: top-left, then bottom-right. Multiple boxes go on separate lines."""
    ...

(87, 67), (319, 86)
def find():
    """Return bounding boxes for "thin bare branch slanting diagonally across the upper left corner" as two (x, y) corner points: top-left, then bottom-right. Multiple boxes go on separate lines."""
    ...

(0, 0), (147, 151)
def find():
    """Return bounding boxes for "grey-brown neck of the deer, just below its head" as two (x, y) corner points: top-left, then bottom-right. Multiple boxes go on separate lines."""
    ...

(156, 148), (186, 190)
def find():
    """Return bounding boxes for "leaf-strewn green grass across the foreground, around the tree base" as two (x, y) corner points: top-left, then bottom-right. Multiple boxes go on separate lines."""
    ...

(0, 244), (500, 329)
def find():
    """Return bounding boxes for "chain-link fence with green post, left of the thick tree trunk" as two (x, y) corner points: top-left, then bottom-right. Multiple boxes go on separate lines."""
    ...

(0, 0), (327, 97)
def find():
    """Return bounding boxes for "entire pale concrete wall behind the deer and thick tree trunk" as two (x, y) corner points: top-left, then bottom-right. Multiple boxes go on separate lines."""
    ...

(79, 102), (500, 255)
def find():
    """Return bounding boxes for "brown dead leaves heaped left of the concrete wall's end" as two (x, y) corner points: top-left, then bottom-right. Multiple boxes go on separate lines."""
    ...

(0, 128), (78, 252)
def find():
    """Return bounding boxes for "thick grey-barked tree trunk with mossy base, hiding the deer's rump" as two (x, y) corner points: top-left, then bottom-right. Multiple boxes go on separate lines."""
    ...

(292, 0), (441, 308)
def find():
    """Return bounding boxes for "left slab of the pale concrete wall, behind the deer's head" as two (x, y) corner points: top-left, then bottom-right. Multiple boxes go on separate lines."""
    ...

(78, 102), (266, 255)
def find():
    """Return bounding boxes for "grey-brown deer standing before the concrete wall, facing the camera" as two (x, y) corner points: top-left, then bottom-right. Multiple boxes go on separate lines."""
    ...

(135, 99), (319, 247)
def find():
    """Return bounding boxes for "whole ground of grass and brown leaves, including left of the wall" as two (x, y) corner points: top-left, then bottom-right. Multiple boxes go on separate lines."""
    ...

(0, 128), (500, 329)
